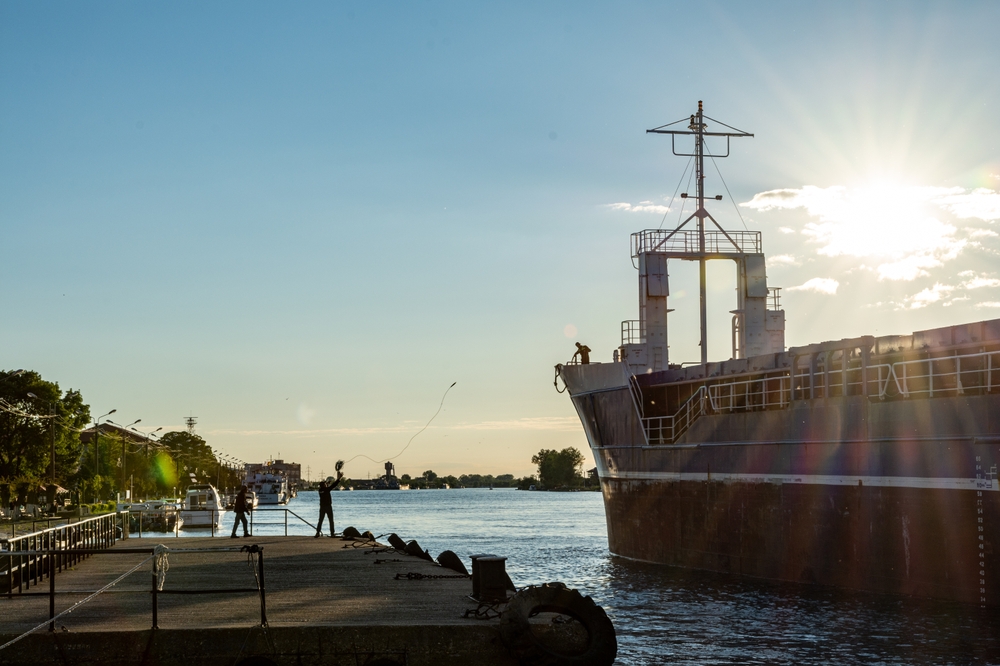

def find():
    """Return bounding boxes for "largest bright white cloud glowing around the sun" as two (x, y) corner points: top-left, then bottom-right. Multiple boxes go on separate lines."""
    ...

(740, 185), (1000, 281)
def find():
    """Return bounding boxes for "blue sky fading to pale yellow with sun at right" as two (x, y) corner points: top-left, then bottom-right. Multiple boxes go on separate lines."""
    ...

(0, 0), (1000, 478)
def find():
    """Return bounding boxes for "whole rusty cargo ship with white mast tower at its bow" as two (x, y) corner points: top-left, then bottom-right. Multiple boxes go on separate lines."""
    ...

(556, 102), (1000, 607)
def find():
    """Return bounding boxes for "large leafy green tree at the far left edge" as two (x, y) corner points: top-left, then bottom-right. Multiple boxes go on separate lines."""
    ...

(0, 370), (90, 485)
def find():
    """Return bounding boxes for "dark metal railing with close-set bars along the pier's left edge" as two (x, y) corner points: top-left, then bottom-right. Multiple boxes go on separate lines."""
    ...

(0, 513), (122, 597)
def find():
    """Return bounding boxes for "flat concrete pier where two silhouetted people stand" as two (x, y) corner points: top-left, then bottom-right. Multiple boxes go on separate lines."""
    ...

(0, 537), (532, 666)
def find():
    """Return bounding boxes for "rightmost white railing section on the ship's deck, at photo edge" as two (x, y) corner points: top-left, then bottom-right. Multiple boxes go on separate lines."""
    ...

(882, 351), (1000, 398)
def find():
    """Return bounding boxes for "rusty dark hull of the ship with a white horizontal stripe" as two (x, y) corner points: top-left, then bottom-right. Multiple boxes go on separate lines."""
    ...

(571, 360), (1000, 606)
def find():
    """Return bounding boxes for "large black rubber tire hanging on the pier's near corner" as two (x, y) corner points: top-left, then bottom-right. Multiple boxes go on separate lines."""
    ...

(500, 583), (618, 666)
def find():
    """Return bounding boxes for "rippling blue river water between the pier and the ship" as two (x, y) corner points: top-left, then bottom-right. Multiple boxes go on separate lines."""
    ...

(150, 489), (1000, 664)
